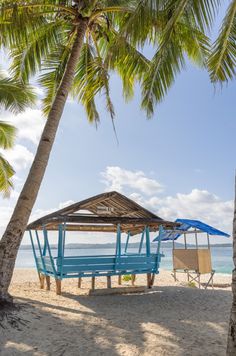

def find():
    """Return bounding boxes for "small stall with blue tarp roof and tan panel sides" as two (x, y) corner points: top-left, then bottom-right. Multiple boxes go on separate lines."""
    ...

(154, 219), (230, 288)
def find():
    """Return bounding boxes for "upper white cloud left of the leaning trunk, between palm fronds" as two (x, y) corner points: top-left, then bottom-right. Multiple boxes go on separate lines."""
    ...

(0, 108), (46, 145)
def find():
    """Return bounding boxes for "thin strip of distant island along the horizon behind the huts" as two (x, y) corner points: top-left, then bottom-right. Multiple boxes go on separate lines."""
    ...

(20, 241), (232, 250)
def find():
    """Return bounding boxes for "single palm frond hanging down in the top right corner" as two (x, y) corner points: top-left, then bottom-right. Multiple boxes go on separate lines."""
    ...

(208, 0), (236, 82)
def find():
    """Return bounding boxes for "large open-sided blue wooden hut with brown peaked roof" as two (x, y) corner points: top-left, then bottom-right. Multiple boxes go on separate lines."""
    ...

(27, 192), (176, 294)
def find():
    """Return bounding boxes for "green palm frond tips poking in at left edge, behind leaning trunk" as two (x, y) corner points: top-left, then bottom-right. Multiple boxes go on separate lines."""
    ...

(0, 73), (35, 196)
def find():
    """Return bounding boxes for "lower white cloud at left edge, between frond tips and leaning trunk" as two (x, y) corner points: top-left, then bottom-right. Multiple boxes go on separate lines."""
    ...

(0, 145), (34, 170)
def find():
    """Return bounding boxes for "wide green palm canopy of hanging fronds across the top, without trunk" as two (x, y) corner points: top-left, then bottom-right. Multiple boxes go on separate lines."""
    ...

(0, 0), (219, 122)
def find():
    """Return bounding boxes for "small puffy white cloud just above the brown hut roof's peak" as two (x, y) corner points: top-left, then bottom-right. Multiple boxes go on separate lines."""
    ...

(101, 167), (163, 195)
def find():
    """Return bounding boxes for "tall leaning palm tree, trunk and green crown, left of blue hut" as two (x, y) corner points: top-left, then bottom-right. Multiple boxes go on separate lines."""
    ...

(0, 0), (153, 301)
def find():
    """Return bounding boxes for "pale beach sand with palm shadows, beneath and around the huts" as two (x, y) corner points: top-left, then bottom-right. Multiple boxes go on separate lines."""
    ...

(0, 269), (231, 356)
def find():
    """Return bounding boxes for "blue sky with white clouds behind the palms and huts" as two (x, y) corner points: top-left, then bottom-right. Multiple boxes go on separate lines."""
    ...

(0, 4), (236, 244)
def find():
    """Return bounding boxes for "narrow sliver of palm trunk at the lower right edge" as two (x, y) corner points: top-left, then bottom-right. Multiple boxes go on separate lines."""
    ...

(226, 177), (236, 356)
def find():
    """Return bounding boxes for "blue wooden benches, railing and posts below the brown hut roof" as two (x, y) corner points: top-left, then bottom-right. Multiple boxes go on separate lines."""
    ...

(30, 225), (162, 294)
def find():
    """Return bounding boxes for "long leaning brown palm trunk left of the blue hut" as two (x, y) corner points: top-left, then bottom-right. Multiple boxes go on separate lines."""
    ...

(0, 19), (88, 302)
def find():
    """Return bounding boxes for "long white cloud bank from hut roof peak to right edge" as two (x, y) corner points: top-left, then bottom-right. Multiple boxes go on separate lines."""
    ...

(102, 167), (233, 233)
